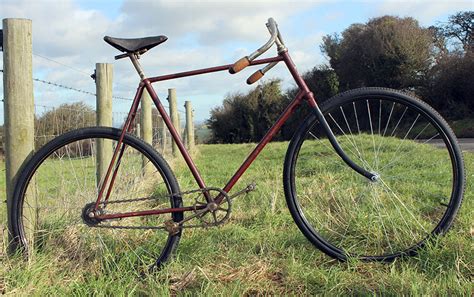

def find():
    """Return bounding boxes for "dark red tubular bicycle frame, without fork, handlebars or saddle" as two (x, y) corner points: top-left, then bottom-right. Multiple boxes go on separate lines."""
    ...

(96, 52), (316, 219)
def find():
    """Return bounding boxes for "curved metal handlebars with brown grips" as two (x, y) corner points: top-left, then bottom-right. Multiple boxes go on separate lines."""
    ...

(229, 18), (286, 84)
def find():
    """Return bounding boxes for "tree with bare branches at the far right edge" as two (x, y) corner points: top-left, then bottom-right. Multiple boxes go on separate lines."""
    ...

(419, 11), (474, 119)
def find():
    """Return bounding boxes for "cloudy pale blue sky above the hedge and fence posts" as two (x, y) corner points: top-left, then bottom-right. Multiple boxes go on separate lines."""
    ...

(0, 0), (474, 124)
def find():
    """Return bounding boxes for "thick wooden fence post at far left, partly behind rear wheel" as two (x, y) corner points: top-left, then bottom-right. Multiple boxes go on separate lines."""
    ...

(3, 19), (36, 249)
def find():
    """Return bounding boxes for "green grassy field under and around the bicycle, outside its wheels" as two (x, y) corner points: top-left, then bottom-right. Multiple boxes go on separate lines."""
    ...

(0, 143), (474, 296)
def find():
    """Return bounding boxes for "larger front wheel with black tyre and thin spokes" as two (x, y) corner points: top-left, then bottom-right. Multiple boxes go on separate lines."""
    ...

(283, 88), (464, 261)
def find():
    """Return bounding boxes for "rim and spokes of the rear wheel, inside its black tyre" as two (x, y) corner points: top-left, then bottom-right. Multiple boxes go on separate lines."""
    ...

(18, 130), (179, 271)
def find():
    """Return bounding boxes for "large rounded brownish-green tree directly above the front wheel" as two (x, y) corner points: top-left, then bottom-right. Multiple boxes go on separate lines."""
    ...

(321, 16), (433, 90)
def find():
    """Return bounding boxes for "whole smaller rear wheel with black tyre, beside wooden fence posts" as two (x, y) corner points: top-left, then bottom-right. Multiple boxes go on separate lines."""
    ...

(10, 127), (183, 268)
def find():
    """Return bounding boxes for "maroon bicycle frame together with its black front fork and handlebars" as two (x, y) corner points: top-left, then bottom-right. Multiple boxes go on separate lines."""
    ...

(95, 25), (375, 220)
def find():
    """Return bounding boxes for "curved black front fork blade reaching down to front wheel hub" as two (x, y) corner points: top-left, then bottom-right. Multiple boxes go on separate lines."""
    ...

(307, 92), (377, 181)
